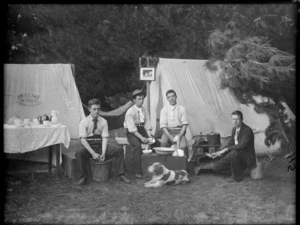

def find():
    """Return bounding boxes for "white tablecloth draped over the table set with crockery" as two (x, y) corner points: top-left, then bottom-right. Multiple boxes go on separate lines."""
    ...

(4, 124), (71, 153)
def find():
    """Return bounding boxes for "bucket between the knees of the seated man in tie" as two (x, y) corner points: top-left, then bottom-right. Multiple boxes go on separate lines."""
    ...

(90, 159), (112, 181)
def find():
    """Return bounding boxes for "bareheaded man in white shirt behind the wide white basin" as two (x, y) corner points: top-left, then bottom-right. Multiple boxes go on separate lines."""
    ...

(160, 90), (189, 155)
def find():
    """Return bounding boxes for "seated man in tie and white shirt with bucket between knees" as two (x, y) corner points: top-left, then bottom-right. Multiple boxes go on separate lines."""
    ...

(76, 99), (130, 185)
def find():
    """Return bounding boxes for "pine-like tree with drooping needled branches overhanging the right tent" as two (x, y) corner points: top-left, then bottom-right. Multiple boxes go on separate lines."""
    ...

(209, 3), (296, 155)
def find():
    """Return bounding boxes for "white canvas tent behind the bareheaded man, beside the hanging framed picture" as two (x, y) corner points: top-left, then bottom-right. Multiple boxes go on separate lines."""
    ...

(145, 58), (295, 155)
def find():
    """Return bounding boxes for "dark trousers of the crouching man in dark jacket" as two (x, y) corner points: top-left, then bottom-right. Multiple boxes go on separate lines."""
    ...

(213, 150), (247, 180)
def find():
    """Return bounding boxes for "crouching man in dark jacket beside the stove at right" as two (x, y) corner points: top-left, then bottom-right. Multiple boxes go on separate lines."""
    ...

(212, 110), (256, 182)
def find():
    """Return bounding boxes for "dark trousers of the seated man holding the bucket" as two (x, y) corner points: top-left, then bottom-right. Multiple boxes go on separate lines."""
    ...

(75, 141), (125, 178)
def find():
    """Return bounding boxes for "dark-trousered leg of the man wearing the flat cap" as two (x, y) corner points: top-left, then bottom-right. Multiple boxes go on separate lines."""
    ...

(127, 133), (142, 174)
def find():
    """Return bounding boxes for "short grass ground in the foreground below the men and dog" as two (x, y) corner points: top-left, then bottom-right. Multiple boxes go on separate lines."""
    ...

(4, 142), (296, 224)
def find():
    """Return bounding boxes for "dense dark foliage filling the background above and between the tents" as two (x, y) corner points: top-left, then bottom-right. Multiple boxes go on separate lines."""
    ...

(6, 4), (295, 109)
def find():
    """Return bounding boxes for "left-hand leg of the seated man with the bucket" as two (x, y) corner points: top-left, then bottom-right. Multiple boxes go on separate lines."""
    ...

(75, 146), (92, 179)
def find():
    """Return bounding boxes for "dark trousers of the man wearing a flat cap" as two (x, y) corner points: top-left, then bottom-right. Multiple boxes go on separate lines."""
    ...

(126, 127), (160, 174)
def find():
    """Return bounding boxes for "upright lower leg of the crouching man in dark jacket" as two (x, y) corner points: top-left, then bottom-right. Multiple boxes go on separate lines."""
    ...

(230, 150), (247, 180)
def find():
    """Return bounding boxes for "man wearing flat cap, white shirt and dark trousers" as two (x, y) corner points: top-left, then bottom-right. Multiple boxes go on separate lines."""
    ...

(124, 90), (160, 179)
